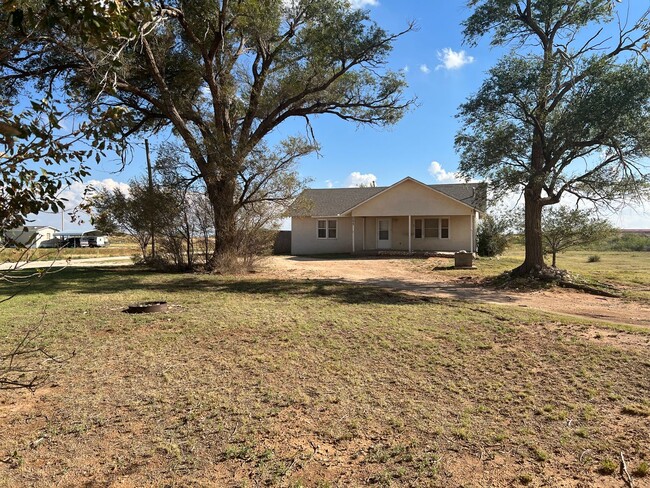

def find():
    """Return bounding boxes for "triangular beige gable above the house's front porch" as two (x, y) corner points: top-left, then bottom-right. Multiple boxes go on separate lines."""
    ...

(352, 181), (472, 217)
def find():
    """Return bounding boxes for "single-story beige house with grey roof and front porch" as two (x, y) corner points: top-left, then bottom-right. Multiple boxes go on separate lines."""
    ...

(290, 177), (486, 255)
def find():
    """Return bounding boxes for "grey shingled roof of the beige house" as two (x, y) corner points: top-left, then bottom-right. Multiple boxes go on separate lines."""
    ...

(289, 177), (487, 217)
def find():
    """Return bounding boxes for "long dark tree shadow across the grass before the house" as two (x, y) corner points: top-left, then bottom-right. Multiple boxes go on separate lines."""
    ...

(0, 267), (437, 304)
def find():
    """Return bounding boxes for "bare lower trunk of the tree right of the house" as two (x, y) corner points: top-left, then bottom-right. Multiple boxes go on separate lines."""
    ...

(512, 188), (546, 276)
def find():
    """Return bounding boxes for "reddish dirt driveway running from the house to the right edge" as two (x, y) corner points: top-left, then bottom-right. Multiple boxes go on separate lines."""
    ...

(264, 256), (650, 326)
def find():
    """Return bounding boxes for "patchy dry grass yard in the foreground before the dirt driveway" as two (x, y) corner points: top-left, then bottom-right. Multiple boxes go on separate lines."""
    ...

(0, 268), (650, 487)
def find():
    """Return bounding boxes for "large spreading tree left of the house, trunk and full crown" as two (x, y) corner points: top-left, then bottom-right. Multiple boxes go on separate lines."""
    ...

(5, 0), (410, 265)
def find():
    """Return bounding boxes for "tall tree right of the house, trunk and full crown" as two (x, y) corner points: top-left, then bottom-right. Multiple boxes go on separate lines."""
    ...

(456, 0), (650, 275)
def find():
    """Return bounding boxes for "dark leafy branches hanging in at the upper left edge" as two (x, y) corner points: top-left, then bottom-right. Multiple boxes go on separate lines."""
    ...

(0, 0), (148, 229)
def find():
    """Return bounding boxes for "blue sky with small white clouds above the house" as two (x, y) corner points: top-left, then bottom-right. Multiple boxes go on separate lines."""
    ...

(37, 0), (650, 228)
